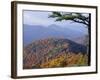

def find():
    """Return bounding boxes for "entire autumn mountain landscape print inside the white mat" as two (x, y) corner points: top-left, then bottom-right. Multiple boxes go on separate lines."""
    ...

(23, 11), (90, 69)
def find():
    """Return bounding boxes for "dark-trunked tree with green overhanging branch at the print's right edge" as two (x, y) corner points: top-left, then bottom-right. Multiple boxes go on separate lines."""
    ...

(49, 12), (91, 58)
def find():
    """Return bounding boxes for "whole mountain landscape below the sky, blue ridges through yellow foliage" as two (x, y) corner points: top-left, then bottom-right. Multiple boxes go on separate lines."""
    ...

(23, 24), (88, 69)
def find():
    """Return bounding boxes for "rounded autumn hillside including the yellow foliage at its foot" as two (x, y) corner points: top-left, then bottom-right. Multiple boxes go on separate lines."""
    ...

(23, 38), (88, 69)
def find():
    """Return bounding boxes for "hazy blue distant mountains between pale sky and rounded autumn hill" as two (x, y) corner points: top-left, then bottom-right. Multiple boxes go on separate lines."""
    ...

(23, 24), (85, 46)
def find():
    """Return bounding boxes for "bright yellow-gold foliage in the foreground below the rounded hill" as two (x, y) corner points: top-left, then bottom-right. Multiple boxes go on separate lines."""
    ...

(40, 53), (88, 68)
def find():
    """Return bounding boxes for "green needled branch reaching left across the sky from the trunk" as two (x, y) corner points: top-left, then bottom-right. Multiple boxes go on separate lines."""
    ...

(49, 12), (89, 26)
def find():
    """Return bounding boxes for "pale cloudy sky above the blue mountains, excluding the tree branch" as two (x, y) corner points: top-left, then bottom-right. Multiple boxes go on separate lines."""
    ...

(23, 10), (88, 34)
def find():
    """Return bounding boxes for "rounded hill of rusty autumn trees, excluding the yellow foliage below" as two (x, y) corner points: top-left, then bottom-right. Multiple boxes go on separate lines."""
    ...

(23, 38), (87, 69)
